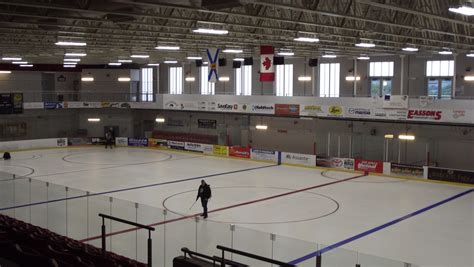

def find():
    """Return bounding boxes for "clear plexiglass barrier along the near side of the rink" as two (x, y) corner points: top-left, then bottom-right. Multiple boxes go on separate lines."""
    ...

(0, 175), (415, 267)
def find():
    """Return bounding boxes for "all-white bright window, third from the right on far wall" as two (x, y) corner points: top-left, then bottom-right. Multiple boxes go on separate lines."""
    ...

(319, 63), (340, 97)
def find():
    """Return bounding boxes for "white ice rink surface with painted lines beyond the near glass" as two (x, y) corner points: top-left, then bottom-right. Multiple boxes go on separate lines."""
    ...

(0, 147), (474, 267)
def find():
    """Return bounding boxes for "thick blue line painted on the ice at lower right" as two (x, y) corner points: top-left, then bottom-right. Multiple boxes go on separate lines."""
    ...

(288, 189), (474, 265)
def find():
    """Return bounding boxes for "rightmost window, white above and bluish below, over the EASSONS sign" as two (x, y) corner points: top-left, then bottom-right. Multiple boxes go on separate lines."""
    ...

(426, 60), (454, 99)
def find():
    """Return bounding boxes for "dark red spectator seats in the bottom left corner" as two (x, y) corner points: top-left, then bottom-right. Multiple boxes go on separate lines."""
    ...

(0, 215), (146, 267)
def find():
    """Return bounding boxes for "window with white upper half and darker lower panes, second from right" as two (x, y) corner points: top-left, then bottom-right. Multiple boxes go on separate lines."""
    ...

(369, 61), (393, 96)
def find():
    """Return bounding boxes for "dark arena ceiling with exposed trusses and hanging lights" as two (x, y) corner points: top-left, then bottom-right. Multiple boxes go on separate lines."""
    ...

(0, 0), (474, 64)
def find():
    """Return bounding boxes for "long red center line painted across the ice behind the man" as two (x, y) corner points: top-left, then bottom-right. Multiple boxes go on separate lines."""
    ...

(79, 174), (367, 242)
